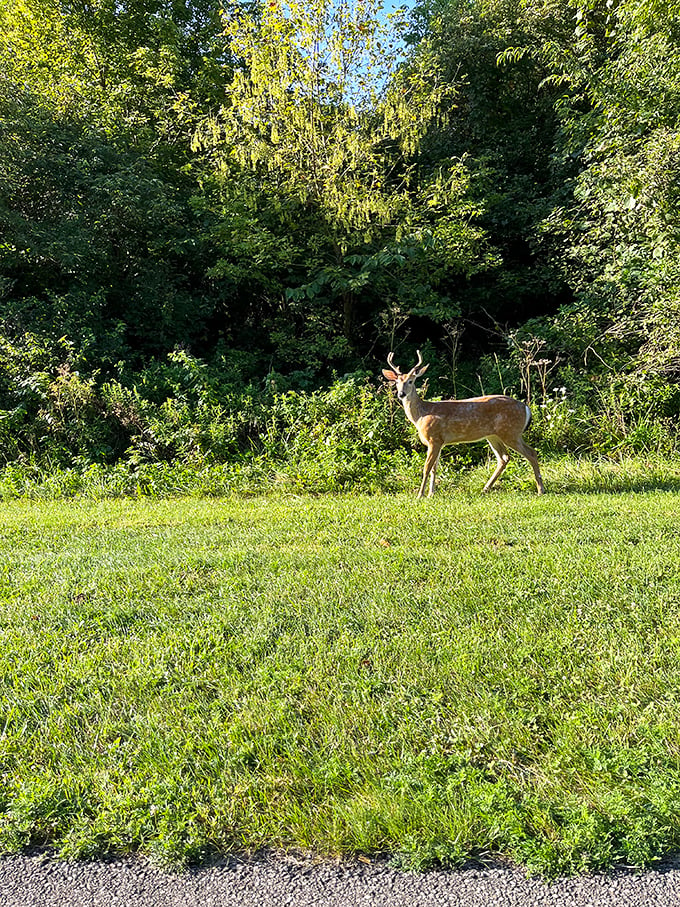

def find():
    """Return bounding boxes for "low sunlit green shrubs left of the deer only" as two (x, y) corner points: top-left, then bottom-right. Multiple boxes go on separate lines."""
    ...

(0, 335), (422, 491)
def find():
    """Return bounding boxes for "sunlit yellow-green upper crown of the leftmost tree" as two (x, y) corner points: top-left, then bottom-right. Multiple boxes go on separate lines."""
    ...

(0, 0), (228, 147)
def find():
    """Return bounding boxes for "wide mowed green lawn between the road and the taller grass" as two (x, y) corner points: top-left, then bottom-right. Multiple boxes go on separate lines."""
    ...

(0, 471), (680, 873)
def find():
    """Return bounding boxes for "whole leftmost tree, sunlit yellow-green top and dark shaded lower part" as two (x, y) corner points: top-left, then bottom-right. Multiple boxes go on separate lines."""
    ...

(0, 0), (231, 367)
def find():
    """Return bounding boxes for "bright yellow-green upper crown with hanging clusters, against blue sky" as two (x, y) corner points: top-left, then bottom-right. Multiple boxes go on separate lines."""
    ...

(215, 0), (422, 217)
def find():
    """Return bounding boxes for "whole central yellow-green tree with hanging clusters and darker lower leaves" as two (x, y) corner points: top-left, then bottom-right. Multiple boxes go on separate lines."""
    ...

(197, 0), (484, 366)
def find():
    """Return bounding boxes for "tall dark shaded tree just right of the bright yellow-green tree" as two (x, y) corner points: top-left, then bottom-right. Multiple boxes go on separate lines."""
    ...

(415, 0), (574, 336)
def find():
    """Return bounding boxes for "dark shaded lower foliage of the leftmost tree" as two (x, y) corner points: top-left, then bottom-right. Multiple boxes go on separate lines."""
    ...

(0, 98), (223, 367)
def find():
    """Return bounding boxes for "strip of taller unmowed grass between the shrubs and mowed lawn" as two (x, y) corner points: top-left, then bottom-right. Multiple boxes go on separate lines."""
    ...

(0, 454), (680, 501)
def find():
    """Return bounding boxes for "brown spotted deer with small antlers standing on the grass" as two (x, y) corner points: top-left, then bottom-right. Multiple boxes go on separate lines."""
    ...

(382, 350), (545, 498)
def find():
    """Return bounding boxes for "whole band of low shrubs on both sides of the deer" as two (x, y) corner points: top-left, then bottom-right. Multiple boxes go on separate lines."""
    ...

(0, 336), (680, 493)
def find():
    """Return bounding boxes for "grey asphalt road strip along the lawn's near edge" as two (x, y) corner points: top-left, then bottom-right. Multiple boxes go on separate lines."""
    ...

(0, 854), (680, 907)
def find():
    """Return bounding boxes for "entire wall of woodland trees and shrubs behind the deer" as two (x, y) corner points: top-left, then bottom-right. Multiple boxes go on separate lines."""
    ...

(0, 0), (680, 489)
